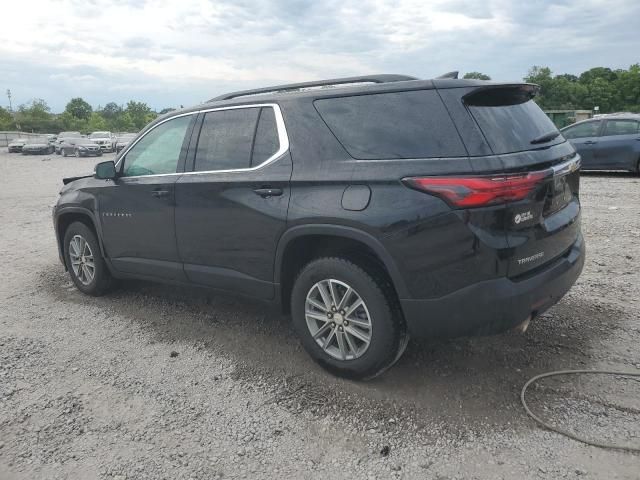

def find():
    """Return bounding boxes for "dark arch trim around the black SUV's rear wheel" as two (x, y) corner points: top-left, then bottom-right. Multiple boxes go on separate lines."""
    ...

(274, 224), (409, 311)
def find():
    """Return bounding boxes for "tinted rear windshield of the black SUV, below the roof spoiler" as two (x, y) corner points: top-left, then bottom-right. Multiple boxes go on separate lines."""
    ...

(469, 100), (564, 154)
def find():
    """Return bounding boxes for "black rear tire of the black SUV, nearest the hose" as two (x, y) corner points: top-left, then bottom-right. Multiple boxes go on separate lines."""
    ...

(291, 257), (408, 380)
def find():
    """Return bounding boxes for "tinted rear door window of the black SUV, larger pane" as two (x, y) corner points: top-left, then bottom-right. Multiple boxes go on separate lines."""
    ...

(195, 108), (260, 171)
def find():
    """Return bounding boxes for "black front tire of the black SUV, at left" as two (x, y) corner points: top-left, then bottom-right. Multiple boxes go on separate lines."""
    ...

(64, 222), (113, 297)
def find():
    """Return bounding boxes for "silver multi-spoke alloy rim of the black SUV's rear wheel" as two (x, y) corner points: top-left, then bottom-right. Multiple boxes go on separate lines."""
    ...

(305, 279), (372, 360)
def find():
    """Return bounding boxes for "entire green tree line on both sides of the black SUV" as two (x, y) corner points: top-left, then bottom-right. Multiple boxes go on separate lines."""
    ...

(0, 63), (640, 133)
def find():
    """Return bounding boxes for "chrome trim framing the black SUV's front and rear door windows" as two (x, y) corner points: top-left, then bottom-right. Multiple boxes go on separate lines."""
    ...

(116, 103), (289, 178)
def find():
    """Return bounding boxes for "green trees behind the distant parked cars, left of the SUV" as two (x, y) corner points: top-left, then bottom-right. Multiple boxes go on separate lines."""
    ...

(0, 97), (173, 134)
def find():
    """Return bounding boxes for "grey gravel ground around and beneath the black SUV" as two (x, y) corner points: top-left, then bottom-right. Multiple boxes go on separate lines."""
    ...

(0, 153), (640, 480)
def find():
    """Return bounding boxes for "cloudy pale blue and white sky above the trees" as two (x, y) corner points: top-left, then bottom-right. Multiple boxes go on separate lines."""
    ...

(0, 0), (640, 112)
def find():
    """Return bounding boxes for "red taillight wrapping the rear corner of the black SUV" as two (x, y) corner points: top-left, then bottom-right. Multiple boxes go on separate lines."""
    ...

(402, 169), (553, 208)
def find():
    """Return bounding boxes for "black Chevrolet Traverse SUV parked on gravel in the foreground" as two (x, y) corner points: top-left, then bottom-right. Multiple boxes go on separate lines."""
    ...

(53, 75), (585, 378)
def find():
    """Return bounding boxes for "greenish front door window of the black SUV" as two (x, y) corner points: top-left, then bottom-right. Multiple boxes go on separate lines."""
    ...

(123, 115), (192, 177)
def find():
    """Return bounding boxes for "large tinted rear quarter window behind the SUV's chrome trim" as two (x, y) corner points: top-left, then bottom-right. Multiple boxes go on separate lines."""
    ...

(314, 90), (466, 160)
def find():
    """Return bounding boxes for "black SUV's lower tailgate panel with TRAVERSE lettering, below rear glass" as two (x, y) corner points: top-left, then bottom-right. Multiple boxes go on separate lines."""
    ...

(506, 154), (580, 277)
